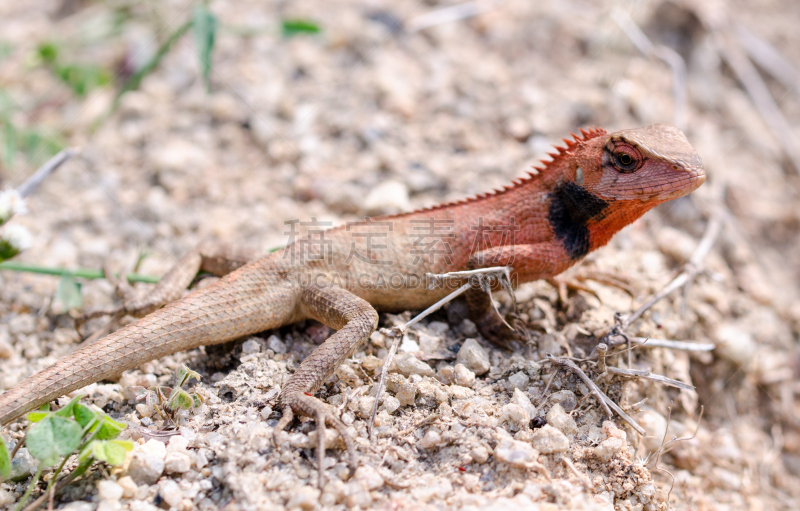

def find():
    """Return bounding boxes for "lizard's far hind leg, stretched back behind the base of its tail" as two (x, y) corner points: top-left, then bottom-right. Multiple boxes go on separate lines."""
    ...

(77, 241), (257, 325)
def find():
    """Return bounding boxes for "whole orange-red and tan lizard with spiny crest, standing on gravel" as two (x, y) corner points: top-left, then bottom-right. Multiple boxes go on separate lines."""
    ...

(0, 124), (705, 485)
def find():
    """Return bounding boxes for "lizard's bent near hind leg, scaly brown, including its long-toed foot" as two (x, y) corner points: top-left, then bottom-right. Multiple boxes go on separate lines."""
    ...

(275, 287), (378, 489)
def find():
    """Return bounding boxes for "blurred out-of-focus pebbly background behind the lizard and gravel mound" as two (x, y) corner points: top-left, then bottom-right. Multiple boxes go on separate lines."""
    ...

(0, 0), (800, 509)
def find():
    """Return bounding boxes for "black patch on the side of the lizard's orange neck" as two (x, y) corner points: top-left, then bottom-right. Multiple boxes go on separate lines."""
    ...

(547, 181), (608, 259)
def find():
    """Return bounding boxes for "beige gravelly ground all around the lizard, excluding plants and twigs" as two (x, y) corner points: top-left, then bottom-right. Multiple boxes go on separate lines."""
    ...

(0, 0), (800, 511)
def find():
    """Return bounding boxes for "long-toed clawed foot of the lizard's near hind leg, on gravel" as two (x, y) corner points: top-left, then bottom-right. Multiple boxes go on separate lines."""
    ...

(272, 394), (358, 490)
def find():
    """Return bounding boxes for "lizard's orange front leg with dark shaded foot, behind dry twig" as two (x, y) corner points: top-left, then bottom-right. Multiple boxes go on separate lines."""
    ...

(466, 243), (571, 349)
